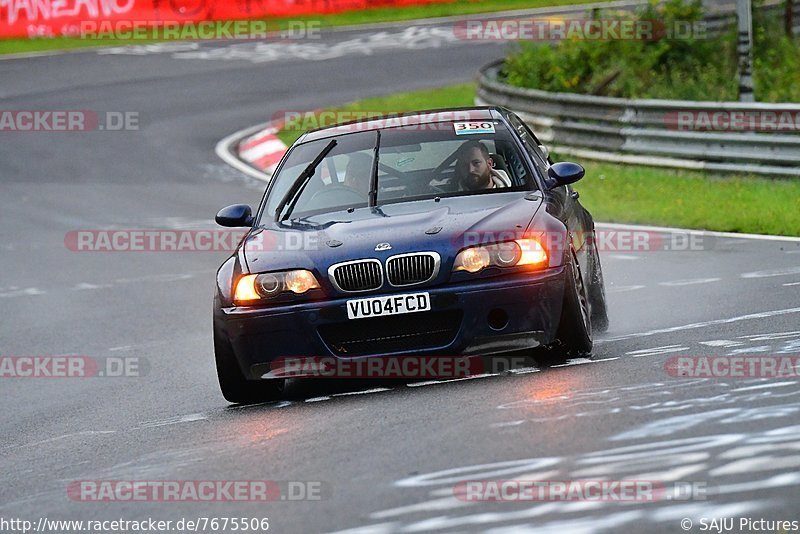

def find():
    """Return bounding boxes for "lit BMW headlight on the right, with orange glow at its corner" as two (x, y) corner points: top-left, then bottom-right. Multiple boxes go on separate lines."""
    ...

(453, 239), (547, 273)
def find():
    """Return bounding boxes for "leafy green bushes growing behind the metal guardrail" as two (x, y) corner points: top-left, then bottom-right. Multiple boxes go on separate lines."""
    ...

(503, 0), (800, 102)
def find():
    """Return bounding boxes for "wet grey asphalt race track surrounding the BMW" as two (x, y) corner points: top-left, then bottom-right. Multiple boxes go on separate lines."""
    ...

(0, 7), (800, 533)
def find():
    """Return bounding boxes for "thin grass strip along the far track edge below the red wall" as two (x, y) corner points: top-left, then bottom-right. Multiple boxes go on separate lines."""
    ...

(0, 0), (592, 54)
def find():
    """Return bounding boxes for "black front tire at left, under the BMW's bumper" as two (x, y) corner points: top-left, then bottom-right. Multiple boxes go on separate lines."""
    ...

(214, 331), (285, 404)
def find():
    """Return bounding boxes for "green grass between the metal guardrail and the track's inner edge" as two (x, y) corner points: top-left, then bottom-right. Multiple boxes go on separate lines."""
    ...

(278, 84), (800, 236)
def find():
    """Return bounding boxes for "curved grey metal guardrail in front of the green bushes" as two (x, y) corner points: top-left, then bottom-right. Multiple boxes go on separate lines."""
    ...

(476, 2), (800, 176)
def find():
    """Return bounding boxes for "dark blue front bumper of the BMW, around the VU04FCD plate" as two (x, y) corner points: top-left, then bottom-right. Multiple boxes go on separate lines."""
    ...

(215, 267), (564, 379)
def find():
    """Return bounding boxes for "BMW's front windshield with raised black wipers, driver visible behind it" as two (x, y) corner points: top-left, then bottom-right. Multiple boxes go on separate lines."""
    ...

(262, 121), (534, 224)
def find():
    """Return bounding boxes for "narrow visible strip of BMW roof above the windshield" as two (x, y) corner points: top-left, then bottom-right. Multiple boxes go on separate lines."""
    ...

(295, 106), (506, 144)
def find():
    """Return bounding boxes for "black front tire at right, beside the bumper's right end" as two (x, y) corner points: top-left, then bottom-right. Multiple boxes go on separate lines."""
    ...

(550, 250), (592, 361)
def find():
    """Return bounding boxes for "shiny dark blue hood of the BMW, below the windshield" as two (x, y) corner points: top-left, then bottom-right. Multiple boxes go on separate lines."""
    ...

(240, 191), (542, 273)
